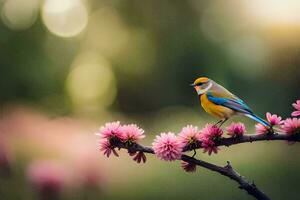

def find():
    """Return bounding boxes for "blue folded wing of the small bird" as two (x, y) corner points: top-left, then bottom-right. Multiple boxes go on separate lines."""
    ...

(207, 92), (253, 114)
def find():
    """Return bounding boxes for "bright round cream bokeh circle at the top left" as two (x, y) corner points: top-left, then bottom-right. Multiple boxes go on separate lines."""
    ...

(42, 0), (88, 37)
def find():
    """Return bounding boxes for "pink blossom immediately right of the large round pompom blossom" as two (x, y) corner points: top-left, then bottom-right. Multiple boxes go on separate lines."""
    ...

(178, 125), (201, 148)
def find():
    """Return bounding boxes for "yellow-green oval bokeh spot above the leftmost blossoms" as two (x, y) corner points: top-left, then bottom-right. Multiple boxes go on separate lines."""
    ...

(66, 52), (116, 112)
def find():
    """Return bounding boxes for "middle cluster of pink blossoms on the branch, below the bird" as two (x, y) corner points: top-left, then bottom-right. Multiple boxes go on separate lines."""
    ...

(152, 123), (246, 162)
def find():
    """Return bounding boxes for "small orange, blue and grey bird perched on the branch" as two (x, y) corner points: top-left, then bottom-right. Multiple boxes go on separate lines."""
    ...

(191, 77), (270, 127)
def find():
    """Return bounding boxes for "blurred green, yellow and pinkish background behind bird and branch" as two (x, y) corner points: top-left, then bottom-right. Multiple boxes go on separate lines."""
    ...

(0, 0), (300, 200)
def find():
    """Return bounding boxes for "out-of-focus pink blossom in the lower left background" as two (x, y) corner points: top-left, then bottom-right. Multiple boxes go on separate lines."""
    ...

(27, 161), (67, 197)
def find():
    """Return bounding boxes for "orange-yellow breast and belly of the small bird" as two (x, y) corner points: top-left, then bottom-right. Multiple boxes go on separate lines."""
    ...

(200, 94), (234, 119)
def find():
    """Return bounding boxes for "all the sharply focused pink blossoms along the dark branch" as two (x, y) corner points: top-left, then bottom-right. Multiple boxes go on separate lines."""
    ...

(98, 100), (300, 172)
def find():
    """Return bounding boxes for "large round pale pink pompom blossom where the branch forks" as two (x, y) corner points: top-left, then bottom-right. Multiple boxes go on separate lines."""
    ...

(152, 132), (183, 161)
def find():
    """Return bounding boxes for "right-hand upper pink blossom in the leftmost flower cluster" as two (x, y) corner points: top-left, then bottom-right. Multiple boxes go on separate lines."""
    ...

(121, 124), (145, 143)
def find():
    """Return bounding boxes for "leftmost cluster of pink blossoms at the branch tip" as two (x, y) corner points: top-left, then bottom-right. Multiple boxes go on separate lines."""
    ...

(96, 121), (146, 163)
